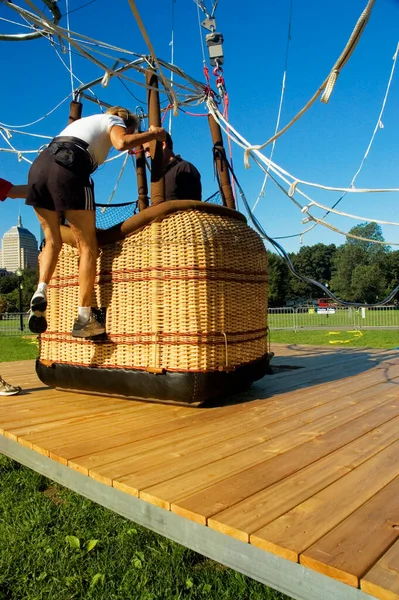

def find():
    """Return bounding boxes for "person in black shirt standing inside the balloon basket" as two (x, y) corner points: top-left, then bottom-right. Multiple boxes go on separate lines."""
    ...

(143, 133), (202, 200)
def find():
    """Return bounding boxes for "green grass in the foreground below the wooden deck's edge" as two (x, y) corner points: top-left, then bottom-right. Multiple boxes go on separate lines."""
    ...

(0, 455), (287, 600)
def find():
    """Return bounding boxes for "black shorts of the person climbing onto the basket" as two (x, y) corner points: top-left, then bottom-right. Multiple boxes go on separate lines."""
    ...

(25, 149), (95, 213)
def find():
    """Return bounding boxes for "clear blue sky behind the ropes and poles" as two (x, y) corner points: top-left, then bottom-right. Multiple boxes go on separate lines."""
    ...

(0, 0), (399, 252)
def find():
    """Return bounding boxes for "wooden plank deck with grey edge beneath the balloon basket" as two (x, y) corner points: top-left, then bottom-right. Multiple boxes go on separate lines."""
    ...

(0, 337), (399, 600)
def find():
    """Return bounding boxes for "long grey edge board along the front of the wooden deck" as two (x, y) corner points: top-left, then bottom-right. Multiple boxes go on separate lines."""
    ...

(0, 435), (374, 600)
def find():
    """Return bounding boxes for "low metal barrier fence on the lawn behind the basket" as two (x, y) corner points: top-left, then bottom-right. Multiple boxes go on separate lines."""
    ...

(0, 306), (399, 336)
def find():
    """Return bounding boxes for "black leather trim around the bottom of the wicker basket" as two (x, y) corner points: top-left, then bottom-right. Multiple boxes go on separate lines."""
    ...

(36, 354), (269, 404)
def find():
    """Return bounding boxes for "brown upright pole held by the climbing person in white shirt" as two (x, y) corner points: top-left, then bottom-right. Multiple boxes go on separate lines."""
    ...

(145, 69), (165, 206)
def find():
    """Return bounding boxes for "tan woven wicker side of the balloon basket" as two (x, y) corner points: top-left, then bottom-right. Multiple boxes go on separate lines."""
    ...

(40, 210), (268, 372)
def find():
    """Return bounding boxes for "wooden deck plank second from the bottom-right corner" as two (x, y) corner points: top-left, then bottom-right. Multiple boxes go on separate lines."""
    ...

(300, 477), (399, 587)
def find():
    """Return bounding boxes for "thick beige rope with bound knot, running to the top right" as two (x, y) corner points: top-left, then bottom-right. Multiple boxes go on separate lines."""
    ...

(244, 0), (375, 169)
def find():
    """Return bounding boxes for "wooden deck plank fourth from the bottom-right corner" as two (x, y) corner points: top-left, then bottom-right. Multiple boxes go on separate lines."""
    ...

(206, 417), (399, 542)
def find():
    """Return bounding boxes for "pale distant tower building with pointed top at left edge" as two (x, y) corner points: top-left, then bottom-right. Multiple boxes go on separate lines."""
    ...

(0, 215), (39, 272)
